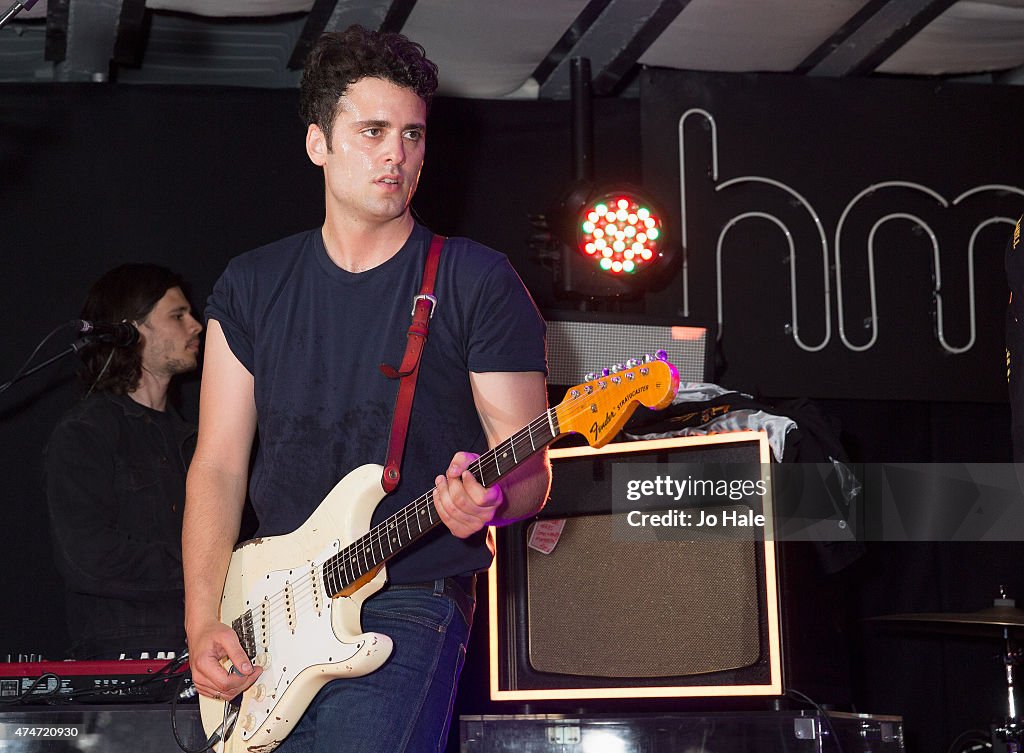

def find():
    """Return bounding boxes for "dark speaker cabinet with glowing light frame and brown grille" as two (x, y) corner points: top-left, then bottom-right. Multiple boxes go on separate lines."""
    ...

(488, 431), (782, 701)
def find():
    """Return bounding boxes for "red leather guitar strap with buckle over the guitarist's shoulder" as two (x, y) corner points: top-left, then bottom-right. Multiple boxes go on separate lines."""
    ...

(380, 236), (444, 494)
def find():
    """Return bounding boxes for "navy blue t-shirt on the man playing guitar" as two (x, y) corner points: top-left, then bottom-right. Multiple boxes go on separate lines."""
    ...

(206, 225), (546, 583)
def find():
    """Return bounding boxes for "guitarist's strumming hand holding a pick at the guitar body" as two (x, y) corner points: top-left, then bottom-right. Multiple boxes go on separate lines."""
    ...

(188, 622), (263, 701)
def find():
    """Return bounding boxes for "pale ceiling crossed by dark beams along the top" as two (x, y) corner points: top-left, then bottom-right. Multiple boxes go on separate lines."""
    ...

(6, 0), (1024, 98)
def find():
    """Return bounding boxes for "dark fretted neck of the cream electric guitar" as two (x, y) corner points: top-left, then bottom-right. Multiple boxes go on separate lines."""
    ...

(324, 408), (561, 593)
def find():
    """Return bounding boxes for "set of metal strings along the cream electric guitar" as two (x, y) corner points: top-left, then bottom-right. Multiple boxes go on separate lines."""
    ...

(232, 368), (667, 631)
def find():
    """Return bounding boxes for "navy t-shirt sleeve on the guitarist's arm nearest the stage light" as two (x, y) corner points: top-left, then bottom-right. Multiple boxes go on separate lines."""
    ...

(468, 257), (548, 375)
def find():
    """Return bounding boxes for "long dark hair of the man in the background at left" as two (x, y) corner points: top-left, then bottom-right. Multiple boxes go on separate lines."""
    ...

(78, 264), (185, 394)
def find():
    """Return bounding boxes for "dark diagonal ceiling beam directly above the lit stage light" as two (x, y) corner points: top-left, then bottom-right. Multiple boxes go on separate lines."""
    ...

(538, 0), (690, 99)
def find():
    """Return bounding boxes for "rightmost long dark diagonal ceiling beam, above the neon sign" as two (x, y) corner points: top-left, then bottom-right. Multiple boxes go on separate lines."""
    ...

(796, 0), (956, 77)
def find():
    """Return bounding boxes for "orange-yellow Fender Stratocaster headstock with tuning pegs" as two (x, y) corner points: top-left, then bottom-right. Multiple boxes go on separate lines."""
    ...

(555, 350), (679, 447)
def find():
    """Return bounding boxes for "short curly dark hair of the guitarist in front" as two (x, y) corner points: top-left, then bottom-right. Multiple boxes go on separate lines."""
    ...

(299, 25), (437, 147)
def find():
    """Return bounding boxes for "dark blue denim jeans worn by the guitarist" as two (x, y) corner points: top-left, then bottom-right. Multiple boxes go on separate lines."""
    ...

(278, 578), (475, 753)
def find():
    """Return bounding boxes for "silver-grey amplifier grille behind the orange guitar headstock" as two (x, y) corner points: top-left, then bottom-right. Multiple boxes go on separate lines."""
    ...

(548, 321), (709, 385)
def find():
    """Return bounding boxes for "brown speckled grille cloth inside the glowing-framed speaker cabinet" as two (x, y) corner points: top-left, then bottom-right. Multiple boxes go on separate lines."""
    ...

(526, 514), (761, 678)
